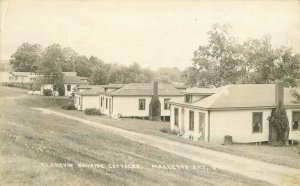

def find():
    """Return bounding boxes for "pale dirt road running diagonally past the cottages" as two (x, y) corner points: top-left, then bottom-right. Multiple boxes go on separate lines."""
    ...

(33, 108), (300, 185)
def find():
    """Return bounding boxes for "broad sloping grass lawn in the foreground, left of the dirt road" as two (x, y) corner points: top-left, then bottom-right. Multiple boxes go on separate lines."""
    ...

(0, 87), (268, 186)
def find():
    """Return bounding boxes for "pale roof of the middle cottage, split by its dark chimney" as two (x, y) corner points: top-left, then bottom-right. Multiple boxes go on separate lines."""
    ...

(109, 83), (182, 96)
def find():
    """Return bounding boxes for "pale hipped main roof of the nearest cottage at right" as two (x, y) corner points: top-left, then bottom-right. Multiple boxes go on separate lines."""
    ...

(172, 84), (300, 109)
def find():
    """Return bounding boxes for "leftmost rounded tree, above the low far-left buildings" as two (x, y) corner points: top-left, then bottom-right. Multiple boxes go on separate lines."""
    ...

(9, 43), (43, 72)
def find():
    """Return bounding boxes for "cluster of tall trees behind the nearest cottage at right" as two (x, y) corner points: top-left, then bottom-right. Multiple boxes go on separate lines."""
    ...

(183, 24), (300, 87)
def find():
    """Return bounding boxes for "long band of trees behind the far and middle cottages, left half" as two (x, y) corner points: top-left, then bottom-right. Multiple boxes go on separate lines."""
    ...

(10, 43), (182, 84)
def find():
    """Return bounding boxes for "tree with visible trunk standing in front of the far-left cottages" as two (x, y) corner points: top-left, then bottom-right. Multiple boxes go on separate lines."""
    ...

(39, 44), (64, 102)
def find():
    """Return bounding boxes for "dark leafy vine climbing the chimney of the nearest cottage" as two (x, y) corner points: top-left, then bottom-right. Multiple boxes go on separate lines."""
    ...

(268, 103), (289, 144)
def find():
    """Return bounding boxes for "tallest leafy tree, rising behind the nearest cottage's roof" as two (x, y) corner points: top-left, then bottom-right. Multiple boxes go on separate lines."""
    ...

(184, 24), (242, 87)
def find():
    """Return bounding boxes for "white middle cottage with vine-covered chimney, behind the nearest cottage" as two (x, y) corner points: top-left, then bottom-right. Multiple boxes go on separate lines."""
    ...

(100, 83), (183, 120)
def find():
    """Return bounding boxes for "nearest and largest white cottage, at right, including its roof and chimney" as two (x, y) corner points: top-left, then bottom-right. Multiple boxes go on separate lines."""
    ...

(170, 82), (300, 144)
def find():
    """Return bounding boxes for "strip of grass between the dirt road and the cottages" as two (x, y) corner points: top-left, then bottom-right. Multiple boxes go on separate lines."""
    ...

(52, 105), (300, 169)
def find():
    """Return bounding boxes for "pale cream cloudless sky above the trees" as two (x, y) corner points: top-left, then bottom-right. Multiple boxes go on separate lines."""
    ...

(0, 0), (300, 69)
